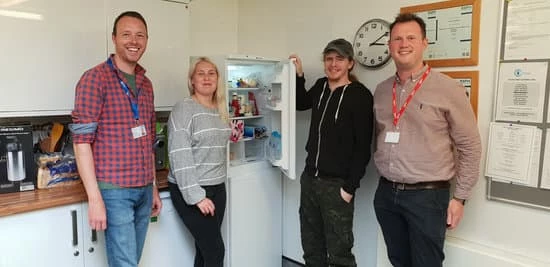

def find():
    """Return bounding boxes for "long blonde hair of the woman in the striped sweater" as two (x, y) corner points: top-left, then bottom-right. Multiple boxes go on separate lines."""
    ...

(187, 57), (229, 121)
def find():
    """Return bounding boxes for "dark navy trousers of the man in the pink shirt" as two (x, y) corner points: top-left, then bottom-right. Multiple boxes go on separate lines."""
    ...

(374, 178), (449, 267)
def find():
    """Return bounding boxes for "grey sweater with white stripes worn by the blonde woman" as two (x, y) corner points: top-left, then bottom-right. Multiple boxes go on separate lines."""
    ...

(168, 98), (231, 205)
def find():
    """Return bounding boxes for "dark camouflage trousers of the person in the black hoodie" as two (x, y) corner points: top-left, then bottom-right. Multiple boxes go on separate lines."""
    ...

(300, 172), (357, 267)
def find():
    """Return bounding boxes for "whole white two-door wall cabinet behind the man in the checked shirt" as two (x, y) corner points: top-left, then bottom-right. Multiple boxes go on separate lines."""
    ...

(0, 0), (189, 117)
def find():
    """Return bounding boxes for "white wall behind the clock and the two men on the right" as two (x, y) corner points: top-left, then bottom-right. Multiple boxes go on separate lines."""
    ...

(191, 0), (550, 267)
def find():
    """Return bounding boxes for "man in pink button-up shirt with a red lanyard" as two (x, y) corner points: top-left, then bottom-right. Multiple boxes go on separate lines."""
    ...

(374, 14), (481, 267)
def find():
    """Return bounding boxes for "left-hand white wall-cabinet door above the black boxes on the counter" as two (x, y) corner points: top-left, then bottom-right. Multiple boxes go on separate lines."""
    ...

(0, 0), (106, 117)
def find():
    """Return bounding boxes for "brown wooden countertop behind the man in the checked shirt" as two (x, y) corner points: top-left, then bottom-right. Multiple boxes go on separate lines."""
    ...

(0, 170), (168, 217)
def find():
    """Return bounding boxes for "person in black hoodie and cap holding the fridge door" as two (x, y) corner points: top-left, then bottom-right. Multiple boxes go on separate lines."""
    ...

(290, 39), (373, 267)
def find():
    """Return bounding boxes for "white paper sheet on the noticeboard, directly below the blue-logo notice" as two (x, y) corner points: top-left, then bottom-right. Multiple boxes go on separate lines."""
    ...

(485, 122), (542, 187)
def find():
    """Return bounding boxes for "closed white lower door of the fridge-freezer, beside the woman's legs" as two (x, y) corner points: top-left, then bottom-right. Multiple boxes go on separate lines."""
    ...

(227, 161), (282, 267)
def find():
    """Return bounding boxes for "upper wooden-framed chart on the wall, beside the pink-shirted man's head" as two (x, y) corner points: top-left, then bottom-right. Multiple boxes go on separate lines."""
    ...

(400, 0), (481, 67)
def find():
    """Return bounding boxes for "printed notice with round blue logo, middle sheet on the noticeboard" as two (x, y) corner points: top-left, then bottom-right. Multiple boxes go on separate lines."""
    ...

(496, 62), (548, 123)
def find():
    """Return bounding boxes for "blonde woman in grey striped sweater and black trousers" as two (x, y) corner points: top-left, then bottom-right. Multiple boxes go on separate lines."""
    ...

(168, 57), (231, 267)
